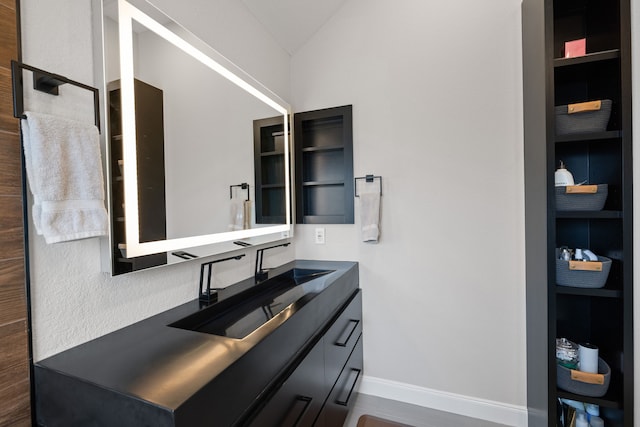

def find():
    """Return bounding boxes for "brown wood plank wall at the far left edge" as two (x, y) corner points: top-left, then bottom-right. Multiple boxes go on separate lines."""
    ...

(0, 0), (31, 427)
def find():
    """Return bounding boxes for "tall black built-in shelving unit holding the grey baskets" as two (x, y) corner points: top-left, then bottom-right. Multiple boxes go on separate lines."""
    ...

(523, 0), (635, 427)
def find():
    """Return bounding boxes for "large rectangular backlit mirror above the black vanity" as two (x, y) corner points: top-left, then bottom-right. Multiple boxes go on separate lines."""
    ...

(103, 0), (291, 274)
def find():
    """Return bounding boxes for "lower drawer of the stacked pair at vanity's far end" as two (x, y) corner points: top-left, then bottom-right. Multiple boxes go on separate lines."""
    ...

(316, 336), (363, 427)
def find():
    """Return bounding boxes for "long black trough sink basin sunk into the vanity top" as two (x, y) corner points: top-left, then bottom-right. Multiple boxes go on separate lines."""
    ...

(169, 268), (335, 339)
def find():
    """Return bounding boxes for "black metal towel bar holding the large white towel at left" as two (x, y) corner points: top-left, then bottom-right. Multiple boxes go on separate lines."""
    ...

(11, 60), (100, 130)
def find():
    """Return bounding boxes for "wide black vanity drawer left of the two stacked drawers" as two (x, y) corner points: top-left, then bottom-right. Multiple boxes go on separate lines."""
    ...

(248, 340), (327, 427)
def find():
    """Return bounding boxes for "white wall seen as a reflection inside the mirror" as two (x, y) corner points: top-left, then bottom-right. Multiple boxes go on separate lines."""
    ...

(134, 26), (283, 239)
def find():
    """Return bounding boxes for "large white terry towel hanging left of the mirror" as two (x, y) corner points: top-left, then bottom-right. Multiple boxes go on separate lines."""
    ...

(22, 111), (108, 243)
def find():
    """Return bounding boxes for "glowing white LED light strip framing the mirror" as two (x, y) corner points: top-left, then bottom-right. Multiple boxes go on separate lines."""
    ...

(118, 0), (291, 258)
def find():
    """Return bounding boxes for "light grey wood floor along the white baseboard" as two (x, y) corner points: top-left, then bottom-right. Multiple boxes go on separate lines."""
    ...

(344, 394), (507, 427)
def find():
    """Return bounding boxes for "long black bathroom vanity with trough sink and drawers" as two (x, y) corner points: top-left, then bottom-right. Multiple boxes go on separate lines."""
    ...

(34, 260), (363, 427)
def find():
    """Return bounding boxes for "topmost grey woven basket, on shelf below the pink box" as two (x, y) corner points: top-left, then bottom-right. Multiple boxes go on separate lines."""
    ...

(555, 99), (612, 135)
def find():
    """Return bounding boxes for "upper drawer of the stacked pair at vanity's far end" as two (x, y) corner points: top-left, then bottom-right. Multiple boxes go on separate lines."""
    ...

(324, 290), (362, 389)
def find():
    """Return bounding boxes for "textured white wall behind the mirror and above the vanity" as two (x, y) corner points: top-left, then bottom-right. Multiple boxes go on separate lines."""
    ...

(21, 0), (293, 361)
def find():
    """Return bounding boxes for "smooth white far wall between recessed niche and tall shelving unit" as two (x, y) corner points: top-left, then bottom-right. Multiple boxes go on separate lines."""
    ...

(291, 0), (526, 425)
